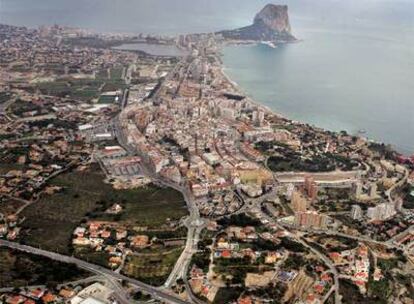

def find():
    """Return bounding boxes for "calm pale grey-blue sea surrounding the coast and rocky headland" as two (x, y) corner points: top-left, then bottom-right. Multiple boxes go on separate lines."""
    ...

(0, 0), (414, 155)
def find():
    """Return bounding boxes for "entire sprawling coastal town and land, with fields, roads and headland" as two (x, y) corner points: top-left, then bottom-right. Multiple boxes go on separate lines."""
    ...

(0, 6), (414, 304)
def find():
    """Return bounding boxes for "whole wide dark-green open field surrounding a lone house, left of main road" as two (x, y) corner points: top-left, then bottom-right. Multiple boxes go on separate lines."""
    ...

(21, 166), (187, 254)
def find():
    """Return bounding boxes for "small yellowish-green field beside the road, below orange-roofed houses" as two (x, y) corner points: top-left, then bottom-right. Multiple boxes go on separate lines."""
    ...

(123, 247), (183, 286)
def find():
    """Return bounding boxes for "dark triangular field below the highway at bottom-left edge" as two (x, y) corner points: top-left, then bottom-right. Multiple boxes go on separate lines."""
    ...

(0, 248), (90, 288)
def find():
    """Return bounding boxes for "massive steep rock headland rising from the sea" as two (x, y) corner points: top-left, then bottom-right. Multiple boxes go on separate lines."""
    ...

(218, 4), (296, 43)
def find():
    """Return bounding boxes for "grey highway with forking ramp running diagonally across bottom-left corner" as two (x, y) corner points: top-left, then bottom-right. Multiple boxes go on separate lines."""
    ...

(0, 240), (189, 304)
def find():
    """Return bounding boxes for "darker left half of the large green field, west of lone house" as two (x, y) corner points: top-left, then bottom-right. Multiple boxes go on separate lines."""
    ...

(21, 167), (102, 253)
